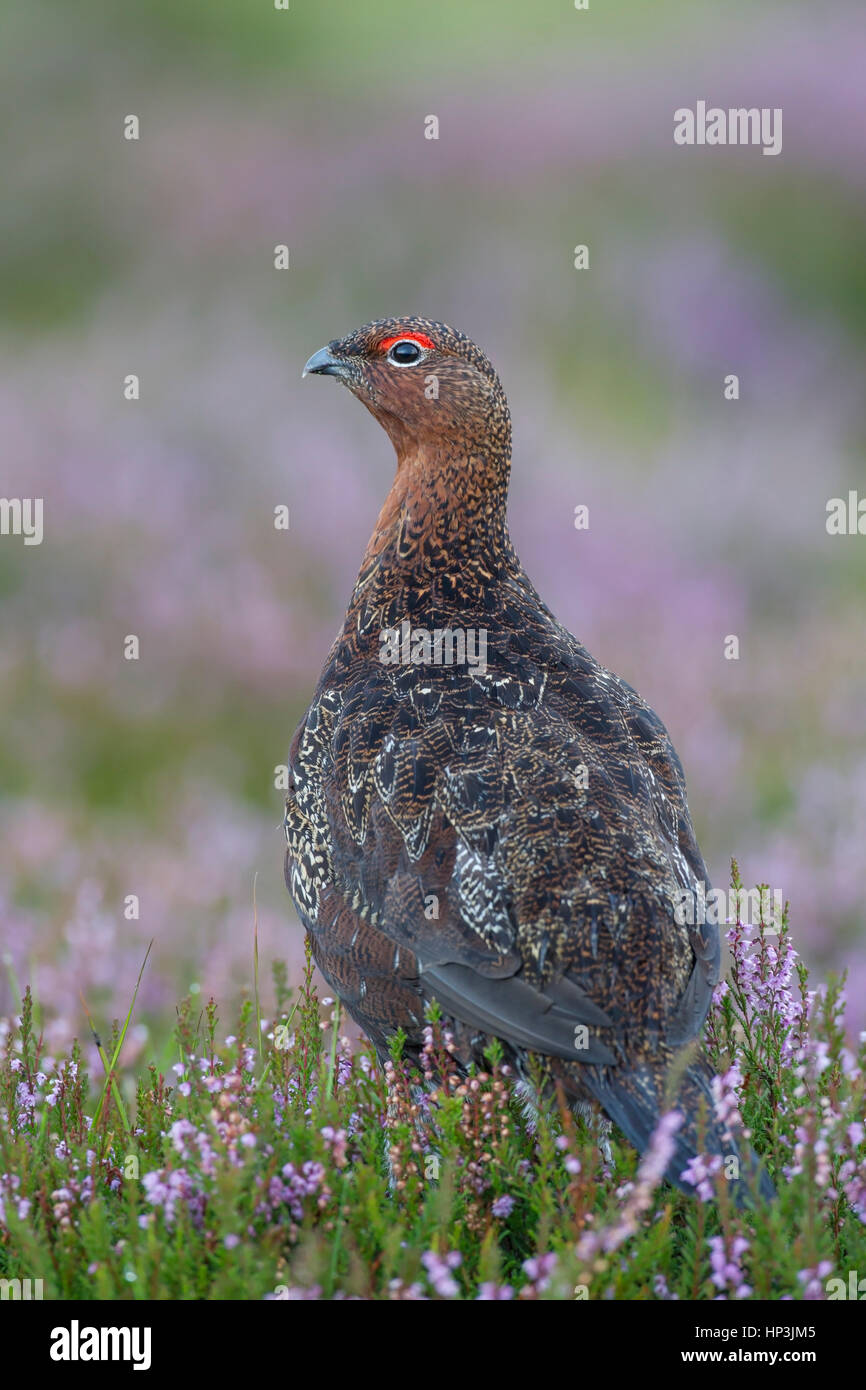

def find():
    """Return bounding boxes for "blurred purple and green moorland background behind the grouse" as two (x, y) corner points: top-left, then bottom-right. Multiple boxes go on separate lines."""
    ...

(0, 0), (866, 1047)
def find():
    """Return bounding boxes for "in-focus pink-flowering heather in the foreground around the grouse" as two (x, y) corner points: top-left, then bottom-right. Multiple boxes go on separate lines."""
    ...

(0, 865), (866, 1301)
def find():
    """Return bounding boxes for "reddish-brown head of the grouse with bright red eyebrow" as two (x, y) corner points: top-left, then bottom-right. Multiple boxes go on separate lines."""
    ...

(303, 317), (510, 460)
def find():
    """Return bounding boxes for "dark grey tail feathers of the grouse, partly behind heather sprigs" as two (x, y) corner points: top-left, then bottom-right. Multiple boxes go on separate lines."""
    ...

(587, 1059), (776, 1207)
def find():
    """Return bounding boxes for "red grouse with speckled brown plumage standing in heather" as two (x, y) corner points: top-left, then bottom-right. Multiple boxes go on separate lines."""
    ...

(285, 318), (770, 1193)
